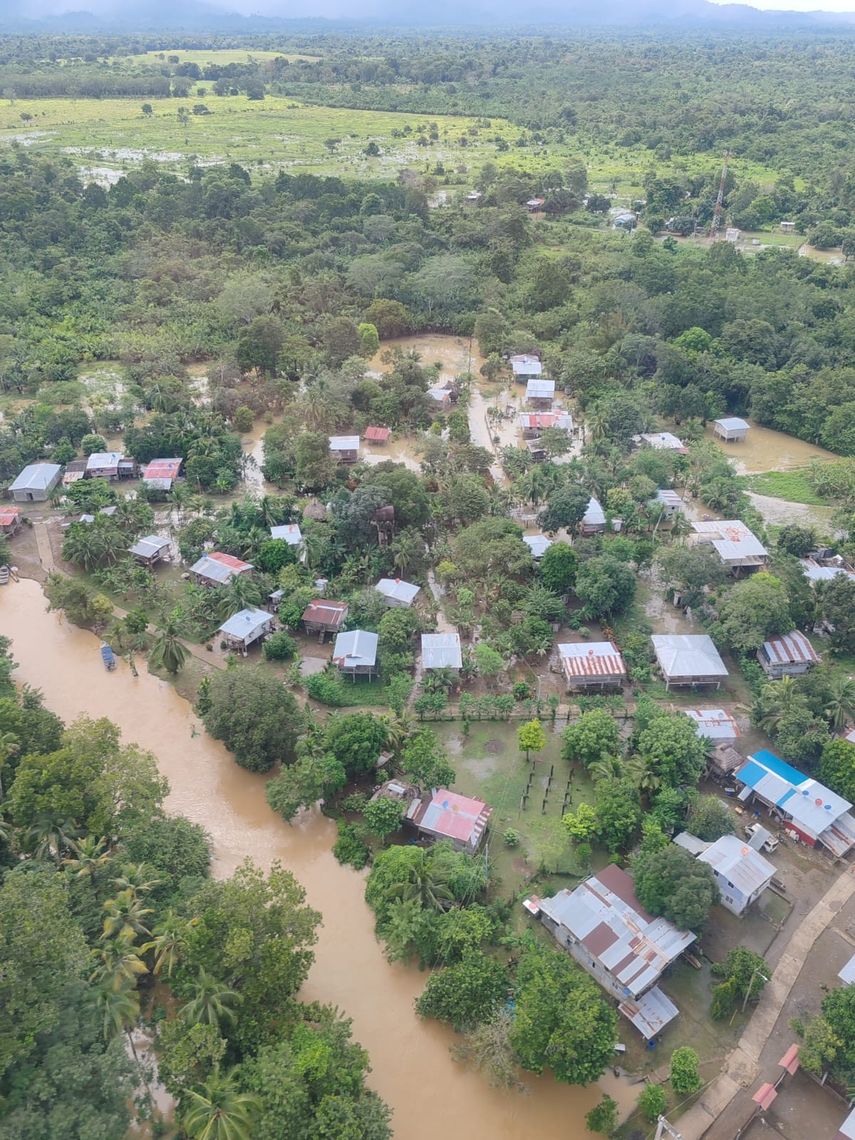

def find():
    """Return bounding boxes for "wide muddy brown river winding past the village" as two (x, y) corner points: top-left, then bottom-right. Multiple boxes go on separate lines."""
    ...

(0, 579), (637, 1140)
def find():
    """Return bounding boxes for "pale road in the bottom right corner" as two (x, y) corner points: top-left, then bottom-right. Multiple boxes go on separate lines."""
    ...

(679, 866), (855, 1140)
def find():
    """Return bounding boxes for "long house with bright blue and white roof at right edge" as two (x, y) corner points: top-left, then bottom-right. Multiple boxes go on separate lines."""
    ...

(734, 749), (855, 858)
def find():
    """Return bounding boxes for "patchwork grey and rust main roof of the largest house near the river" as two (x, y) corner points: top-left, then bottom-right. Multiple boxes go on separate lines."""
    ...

(540, 864), (694, 998)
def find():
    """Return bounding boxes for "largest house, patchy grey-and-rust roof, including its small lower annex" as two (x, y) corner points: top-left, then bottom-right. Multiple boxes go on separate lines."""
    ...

(532, 863), (694, 1041)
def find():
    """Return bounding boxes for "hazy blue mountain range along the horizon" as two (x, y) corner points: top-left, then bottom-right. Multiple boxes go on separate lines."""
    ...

(0, 0), (855, 34)
